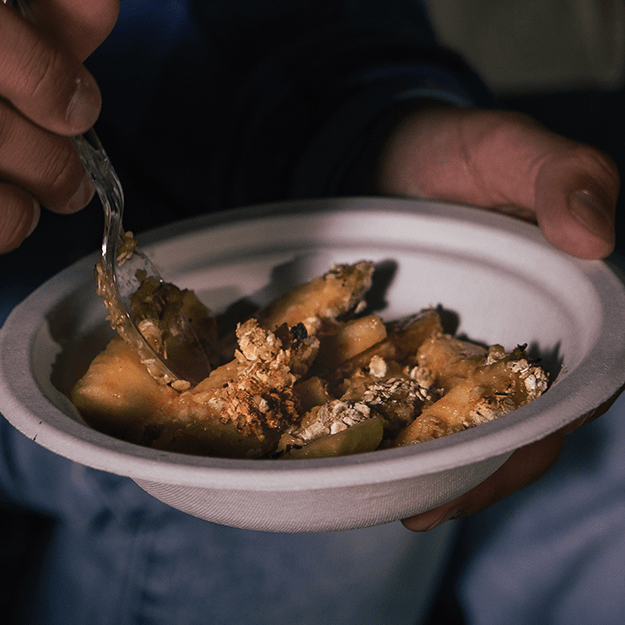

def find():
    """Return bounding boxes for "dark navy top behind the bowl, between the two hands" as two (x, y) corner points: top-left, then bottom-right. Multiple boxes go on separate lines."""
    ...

(90, 0), (489, 229)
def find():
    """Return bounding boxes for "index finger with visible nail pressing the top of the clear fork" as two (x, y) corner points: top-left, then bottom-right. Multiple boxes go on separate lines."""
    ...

(0, 4), (101, 135)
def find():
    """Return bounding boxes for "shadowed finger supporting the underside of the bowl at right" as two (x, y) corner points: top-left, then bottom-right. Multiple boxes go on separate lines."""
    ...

(402, 432), (565, 532)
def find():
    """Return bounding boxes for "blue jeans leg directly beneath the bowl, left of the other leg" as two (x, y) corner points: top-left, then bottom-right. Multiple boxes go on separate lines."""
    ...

(0, 235), (455, 625)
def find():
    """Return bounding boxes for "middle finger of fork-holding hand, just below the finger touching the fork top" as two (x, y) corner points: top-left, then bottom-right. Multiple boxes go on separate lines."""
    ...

(0, 101), (94, 213)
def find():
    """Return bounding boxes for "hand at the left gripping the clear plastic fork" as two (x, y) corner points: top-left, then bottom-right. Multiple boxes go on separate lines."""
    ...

(0, 0), (119, 253)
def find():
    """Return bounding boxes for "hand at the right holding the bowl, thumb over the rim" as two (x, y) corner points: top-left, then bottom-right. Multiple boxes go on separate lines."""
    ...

(377, 104), (620, 531)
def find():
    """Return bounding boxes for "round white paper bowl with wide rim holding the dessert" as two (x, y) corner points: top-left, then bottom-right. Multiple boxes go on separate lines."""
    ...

(0, 199), (625, 532)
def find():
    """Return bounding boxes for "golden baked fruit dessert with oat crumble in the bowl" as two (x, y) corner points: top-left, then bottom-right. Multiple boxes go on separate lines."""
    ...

(71, 261), (547, 459)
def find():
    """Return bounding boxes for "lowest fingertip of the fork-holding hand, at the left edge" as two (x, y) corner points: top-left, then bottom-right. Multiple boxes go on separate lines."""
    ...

(0, 183), (40, 254)
